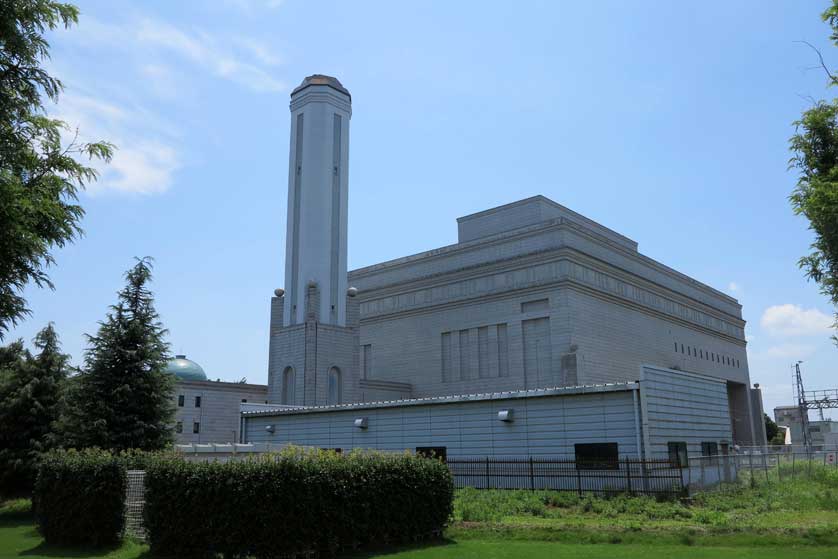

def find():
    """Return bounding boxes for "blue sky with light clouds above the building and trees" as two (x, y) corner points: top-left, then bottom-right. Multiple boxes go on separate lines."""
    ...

(7, 0), (838, 420)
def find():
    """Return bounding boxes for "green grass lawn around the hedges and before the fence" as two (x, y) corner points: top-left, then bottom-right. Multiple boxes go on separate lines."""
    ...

(0, 467), (838, 559)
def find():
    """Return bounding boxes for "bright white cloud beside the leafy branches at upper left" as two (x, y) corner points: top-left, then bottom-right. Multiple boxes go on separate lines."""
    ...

(53, 94), (180, 195)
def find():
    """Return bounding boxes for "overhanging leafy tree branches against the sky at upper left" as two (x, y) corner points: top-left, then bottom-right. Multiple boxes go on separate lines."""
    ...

(0, 0), (113, 338)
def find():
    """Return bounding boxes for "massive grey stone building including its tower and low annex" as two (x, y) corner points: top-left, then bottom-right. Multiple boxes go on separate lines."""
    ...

(243, 75), (765, 456)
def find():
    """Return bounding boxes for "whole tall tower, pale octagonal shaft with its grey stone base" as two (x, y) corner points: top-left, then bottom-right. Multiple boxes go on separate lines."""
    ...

(268, 74), (359, 406)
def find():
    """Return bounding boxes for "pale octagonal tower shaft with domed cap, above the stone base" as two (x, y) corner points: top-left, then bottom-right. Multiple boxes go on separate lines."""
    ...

(283, 74), (352, 326)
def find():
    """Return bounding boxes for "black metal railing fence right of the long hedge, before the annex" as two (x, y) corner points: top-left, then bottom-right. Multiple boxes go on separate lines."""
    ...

(447, 457), (685, 496)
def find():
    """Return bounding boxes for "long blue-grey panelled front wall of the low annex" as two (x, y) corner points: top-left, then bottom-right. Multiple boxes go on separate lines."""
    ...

(245, 385), (639, 458)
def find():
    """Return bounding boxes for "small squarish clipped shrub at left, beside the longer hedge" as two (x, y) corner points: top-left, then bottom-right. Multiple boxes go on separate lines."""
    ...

(33, 450), (126, 546)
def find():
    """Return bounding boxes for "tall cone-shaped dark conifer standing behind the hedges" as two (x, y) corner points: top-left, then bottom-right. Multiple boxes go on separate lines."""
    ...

(59, 258), (174, 450)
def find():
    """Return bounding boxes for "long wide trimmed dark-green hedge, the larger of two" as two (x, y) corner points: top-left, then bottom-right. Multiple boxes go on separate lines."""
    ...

(145, 449), (454, 558)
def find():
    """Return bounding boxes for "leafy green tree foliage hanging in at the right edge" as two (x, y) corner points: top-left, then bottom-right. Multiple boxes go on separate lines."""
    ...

(789, 0), (838, 343)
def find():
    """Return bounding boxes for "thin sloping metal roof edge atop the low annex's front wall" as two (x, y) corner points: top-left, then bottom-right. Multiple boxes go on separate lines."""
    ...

(242, 382), (640, 417)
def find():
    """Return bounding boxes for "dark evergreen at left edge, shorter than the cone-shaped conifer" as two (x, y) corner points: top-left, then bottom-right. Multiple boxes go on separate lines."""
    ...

(0, 324), (69, 495)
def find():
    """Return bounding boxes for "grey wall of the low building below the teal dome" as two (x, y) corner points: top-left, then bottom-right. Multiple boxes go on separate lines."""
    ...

(173, 380), (268, 444)
